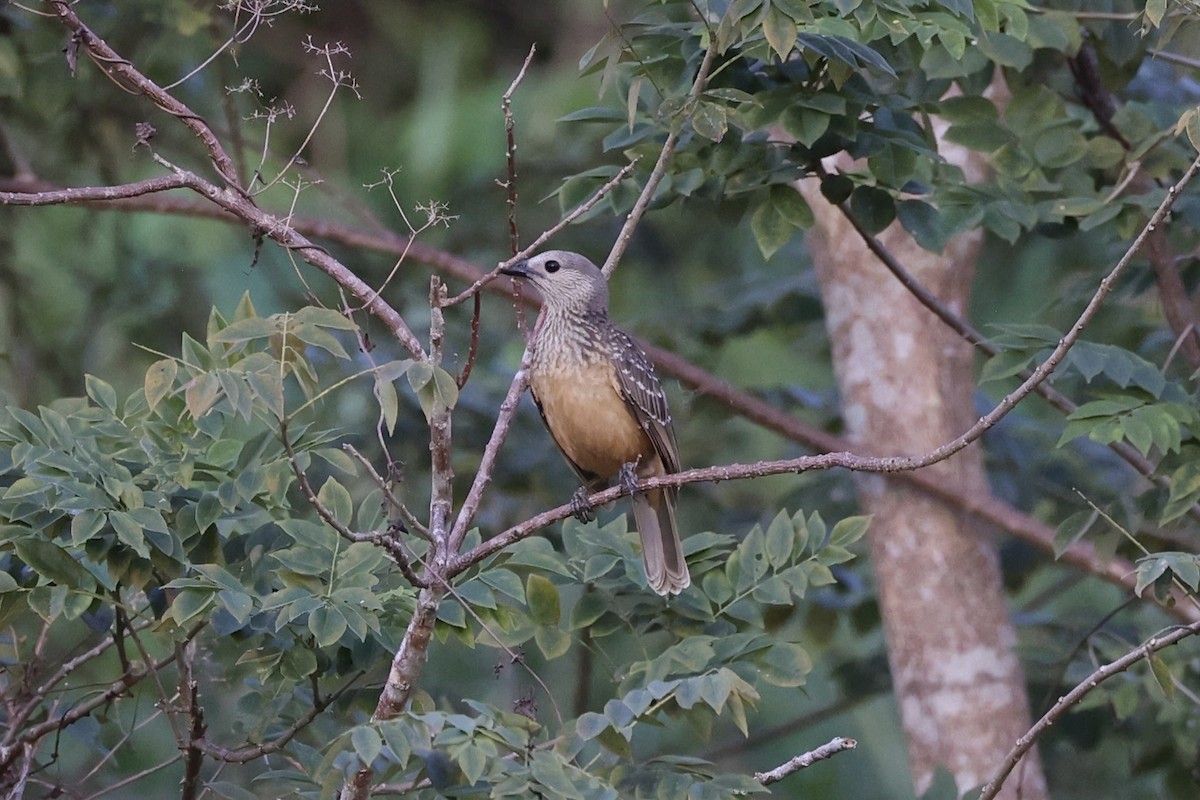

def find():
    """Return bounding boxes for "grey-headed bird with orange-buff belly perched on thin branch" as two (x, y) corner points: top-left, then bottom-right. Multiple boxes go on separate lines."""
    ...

(500, 249), (691, 596)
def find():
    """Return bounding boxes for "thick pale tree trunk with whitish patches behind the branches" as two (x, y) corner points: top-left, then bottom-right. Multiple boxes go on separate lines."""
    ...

(800, 128), (1046, 800)
